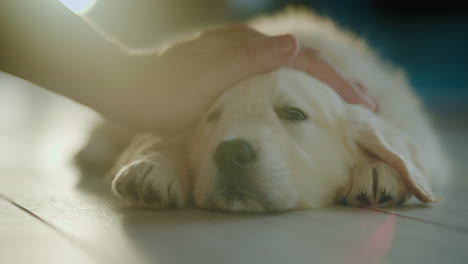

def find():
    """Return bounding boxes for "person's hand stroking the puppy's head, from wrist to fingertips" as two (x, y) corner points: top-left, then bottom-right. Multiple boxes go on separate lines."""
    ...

(119, 26), (376, 133)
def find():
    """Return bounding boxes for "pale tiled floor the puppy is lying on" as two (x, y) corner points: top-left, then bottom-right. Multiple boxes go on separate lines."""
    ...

(0, 72), (468, 264)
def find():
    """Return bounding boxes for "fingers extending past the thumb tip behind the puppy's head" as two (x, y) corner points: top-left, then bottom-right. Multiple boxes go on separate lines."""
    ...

(289, 48), (378, 111)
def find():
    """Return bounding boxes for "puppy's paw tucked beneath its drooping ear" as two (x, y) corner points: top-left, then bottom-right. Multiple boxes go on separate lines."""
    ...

(344, 161), (410, 206)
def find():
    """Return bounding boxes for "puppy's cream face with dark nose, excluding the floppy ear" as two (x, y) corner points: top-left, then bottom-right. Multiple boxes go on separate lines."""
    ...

(189, 69), (436, 211)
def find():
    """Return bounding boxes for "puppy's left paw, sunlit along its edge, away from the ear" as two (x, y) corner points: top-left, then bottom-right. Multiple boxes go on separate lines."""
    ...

(112, 158), (188, 209)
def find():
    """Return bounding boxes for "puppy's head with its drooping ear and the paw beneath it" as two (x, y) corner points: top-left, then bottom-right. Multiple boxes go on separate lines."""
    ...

(189, 69), (435, 212)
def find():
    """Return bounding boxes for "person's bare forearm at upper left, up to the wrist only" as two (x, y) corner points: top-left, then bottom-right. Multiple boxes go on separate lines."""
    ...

(0, 0), (138, 122)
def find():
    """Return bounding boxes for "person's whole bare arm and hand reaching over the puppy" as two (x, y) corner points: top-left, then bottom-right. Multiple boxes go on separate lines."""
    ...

(0, 0), (372, 133)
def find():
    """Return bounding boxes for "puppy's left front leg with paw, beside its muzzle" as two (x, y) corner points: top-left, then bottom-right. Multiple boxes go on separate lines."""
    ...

(111, 135), (190, 209)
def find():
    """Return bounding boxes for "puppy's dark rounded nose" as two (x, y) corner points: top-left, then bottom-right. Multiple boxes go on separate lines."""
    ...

(214, 139), (255, 167)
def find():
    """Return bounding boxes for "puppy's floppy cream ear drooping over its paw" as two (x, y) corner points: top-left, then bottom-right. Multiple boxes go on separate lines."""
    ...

(346, 106), (436, 203)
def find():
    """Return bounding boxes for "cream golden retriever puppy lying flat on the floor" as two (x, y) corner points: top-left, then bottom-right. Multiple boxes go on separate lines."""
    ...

(78, 10), (447, 212)
